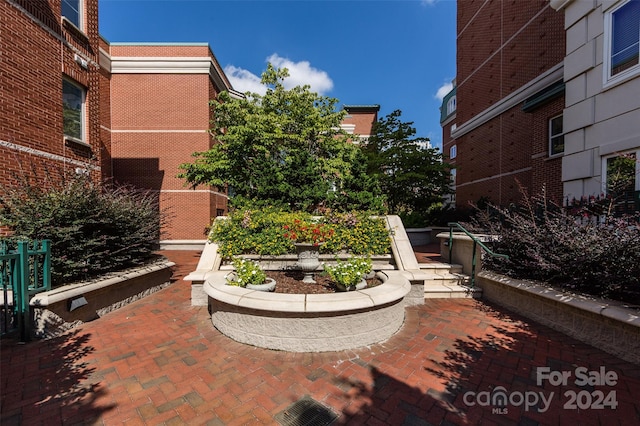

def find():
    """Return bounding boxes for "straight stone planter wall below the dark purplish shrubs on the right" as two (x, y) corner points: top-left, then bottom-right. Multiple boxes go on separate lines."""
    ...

(476, 271), (640, 365)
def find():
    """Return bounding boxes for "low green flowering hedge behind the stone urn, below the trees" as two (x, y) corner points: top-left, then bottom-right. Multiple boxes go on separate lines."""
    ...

(209, 207), (391, 258)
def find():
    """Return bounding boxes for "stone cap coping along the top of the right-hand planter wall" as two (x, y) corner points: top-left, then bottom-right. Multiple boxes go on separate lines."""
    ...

(478, 271), (640, 327)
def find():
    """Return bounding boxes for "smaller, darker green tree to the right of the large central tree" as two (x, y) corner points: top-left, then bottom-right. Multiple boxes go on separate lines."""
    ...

(364, 110), (449, 214)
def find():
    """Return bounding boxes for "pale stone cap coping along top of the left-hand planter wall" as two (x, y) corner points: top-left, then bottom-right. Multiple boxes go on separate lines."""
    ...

(29, 261), (175, 306)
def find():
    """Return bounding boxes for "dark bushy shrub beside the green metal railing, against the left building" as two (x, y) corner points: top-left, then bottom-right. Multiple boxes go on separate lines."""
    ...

(0, 171), (164, 286)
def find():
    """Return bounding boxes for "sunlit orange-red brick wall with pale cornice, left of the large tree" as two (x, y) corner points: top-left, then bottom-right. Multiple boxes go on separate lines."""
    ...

(111, 46), (226, 240)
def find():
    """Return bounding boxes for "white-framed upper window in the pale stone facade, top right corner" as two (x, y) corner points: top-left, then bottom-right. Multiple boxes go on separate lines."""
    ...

(603, 0), (640, 85)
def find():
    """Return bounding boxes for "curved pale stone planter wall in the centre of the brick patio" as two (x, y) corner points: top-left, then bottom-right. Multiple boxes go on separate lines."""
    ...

(204, 271), (411, 352)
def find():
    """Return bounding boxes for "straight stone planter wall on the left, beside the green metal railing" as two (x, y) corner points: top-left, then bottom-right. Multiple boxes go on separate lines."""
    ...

(30, 261), (174, 337)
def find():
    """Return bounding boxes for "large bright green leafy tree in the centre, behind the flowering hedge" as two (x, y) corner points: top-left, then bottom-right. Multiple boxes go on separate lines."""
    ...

(179, 64), (382, 211)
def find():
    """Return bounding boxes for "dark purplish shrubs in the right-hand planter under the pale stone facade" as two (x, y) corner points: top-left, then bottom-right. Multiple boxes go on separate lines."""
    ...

(476, 188), (640, 303)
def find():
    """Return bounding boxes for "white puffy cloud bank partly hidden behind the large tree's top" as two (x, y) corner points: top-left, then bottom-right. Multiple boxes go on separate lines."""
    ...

(224, 53), (333, 95)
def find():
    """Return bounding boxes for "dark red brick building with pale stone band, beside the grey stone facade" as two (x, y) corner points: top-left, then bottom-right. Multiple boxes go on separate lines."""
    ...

(441, 0), (565, 208)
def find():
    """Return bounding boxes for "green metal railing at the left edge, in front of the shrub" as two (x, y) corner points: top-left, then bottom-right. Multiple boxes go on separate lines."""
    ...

(0, 240), (51, 341)
